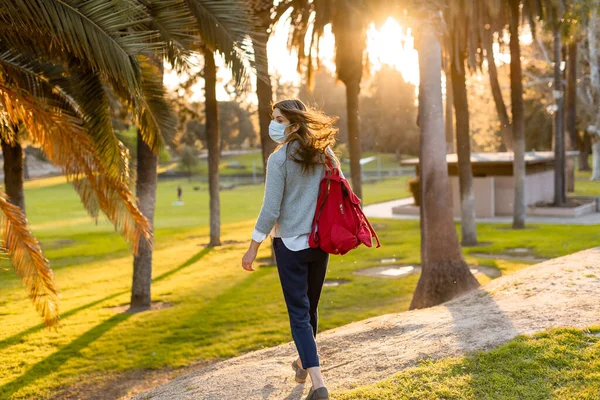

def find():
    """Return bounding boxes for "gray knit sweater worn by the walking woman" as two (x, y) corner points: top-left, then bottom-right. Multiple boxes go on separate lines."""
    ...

(254, 141), (339, 237)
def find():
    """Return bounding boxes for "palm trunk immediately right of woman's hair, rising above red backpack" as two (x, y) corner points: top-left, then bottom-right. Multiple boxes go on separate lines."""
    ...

(344, 80), (363, 199)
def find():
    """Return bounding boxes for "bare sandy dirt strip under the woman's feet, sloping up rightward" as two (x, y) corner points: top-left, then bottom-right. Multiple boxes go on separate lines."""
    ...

(135, 248), (600, 400)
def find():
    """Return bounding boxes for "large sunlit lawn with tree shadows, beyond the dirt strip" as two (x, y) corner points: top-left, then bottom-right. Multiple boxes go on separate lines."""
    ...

(0, 173), (600, 398)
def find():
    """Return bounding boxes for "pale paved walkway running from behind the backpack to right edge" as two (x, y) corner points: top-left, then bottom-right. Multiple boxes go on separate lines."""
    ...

(363, 197), (600, 225)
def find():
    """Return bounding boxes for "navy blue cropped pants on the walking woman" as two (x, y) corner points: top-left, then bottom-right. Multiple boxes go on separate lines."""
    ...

(273, 238), (329, 368)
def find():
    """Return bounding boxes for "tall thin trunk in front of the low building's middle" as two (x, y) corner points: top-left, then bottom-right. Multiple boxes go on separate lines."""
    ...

(509, 0), (527, 229)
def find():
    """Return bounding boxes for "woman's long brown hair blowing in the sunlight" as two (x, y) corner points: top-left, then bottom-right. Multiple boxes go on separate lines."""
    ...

(273, 99), (339, 173)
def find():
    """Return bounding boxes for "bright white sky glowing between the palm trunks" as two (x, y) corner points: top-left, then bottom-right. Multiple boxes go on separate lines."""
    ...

(164, 16), (419, 102)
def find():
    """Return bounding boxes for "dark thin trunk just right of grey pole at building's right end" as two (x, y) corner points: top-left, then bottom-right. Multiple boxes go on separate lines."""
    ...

(566, 39), (578, 192)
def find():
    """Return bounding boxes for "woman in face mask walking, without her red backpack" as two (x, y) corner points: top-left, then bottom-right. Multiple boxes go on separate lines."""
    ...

(242, 100), (339, 400)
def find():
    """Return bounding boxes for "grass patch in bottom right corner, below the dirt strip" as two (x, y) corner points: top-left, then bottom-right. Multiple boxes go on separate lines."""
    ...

(331, 327), (600, 400)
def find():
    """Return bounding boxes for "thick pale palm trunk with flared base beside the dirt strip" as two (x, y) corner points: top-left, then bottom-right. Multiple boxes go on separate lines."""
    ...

(410, 25), (479, 309)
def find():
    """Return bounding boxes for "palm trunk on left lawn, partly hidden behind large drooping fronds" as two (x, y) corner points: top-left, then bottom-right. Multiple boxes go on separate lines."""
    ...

(130, 129), (158, 311)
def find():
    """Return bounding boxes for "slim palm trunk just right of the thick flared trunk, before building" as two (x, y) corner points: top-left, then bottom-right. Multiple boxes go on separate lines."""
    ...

(450, 40), (477, 246)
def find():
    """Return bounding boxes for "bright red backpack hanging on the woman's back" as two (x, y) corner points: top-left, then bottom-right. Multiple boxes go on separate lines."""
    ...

(308, 158), (381, 255)
